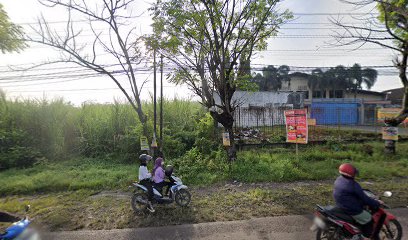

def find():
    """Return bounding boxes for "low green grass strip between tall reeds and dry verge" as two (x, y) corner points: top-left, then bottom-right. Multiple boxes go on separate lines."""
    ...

(0, 142), (408, 196)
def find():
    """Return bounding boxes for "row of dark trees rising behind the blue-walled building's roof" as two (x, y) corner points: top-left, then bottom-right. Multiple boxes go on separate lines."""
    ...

(252, 63), (378, 92)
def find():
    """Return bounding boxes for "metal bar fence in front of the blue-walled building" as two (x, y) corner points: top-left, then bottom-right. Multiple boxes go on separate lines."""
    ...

(234, 104), (394, 143)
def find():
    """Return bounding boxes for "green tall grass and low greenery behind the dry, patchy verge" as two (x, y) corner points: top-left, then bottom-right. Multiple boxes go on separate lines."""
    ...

(0, 94), (408, 196)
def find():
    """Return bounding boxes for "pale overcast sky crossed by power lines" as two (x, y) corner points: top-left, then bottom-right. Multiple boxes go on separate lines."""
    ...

(0, 0), (401, 104)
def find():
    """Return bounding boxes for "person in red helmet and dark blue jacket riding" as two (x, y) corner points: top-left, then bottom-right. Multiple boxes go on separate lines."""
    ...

(333, 163), (382, 239)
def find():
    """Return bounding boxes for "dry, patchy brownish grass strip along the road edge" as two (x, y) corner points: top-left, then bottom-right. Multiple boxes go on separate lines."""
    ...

(0, 178), (408, 231)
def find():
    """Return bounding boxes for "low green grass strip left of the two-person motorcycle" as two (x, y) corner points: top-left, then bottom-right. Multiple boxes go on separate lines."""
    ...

(0, 159), (137, 195)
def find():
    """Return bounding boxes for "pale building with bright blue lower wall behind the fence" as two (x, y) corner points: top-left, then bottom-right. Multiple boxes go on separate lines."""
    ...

(278, 72), (391, 125)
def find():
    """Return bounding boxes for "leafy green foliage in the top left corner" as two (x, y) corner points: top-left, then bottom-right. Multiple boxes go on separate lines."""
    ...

(0, 3), (26, 53)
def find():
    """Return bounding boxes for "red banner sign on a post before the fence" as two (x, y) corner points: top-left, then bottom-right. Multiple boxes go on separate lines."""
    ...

(285, 109), (308, 144)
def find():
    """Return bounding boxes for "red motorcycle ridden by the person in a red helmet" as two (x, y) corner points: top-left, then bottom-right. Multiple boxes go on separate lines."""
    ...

(311, 190), (402, 240)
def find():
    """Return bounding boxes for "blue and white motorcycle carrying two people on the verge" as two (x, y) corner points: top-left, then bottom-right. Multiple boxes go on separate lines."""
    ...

(132, 174), (191, 213)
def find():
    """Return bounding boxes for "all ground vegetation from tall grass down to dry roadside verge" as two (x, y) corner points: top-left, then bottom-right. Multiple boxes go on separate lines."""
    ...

(0, 92), (408, 230)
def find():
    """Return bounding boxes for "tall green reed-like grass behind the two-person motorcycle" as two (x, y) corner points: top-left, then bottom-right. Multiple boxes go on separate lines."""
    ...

(0, 93), (204, 164)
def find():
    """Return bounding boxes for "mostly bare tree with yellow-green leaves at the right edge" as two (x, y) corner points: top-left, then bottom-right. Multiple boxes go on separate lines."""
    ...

(332, 0), (408, 152)
